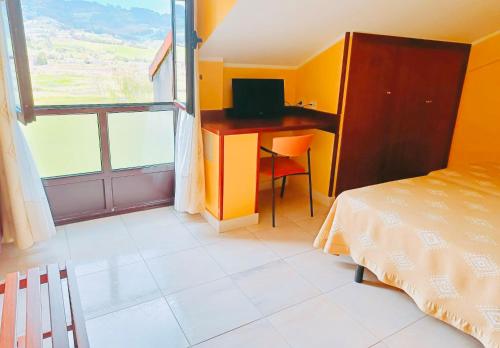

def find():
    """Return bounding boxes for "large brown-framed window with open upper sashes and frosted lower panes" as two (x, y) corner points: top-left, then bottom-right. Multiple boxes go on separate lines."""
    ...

(0, 0), (195, 221)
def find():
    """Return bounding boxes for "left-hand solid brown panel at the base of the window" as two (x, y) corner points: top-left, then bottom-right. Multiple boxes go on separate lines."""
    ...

(45, 180), (106, 220)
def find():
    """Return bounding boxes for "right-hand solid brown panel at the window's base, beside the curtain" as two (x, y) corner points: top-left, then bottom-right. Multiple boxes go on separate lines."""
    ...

(111, 170), (175, 209)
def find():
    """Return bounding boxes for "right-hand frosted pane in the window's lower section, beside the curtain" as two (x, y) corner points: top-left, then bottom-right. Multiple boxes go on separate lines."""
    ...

(108, 111), (174, 169)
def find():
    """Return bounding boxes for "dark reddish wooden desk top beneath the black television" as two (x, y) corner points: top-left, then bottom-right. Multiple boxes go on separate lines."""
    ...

(201, 108), (340, 135)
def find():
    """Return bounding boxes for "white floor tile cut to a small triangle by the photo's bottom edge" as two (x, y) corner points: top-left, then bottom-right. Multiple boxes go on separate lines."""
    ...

(195, 319), (290, 348)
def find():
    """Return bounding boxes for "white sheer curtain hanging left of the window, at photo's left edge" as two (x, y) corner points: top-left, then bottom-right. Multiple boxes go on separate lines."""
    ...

(0, 17), (56, 249)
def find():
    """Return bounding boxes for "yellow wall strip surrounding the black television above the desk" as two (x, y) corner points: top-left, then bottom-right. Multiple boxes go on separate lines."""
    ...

(222, 67), (296, 108)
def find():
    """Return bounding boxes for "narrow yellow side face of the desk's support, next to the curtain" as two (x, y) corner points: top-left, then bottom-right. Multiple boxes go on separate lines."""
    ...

(203, 130), (220, 218)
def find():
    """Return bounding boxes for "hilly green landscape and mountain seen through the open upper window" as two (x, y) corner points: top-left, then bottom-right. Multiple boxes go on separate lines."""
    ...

(22, 0), (172, 105)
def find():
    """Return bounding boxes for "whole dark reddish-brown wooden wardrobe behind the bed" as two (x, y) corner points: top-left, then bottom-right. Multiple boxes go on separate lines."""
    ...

(335, 33), (470, 196)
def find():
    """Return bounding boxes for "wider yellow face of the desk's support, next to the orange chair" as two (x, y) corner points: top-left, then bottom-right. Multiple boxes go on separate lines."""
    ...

(223, 133), (259, 220)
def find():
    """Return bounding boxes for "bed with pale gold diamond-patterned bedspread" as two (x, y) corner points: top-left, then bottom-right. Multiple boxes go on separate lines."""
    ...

(314, 163), (500, 348)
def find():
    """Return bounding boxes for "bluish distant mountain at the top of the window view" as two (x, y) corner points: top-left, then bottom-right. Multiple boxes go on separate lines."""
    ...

(21, 0), (184, 41)
